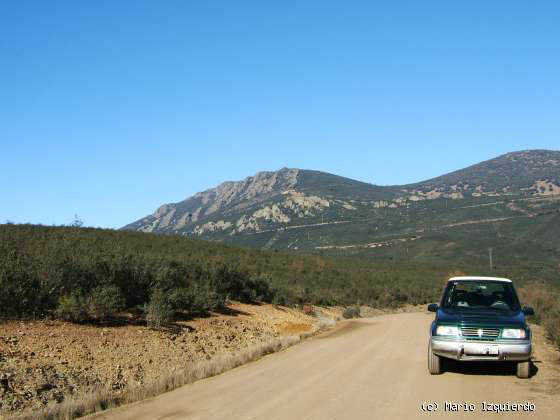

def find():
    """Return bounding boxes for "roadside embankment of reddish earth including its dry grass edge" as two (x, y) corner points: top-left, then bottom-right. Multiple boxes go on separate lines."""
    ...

(0, 303), (341, 418)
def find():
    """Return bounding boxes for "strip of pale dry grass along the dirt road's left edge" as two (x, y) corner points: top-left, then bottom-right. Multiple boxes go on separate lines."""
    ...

(10, 333), (302, 420)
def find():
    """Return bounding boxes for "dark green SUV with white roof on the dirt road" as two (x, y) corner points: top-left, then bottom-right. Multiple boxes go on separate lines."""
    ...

(428, 277), (534, 378)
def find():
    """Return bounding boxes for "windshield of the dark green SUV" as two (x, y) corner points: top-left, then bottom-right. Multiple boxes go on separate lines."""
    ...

(442, 280), (519, 311)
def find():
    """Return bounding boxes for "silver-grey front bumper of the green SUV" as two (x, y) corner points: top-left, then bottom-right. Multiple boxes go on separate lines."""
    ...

(430, 337), (531, 361)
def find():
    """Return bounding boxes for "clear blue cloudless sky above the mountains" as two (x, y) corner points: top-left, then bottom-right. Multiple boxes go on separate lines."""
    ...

(0, 0), (560, 227)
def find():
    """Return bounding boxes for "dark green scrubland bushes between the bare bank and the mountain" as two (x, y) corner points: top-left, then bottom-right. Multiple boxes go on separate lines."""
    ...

(0, 225), (560, 348)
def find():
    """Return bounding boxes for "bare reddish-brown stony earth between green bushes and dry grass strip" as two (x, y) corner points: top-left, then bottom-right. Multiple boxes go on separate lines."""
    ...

(0, 303), (340, 417)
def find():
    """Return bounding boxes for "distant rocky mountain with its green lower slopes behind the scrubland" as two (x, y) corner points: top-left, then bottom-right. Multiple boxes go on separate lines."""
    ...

(124, 150), (560, 265)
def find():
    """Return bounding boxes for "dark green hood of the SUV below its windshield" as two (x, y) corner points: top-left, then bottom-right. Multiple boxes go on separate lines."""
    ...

(436, 308), (525, 327)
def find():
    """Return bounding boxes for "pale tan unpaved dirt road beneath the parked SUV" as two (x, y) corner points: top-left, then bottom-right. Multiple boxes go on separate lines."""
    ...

(92, 313), (560, 420)
